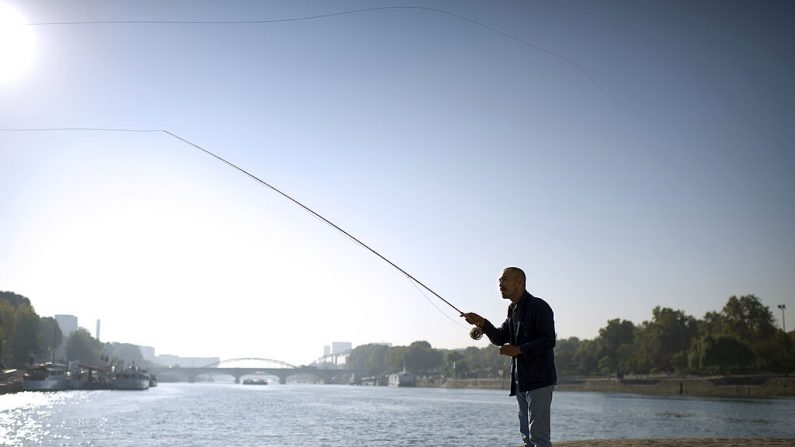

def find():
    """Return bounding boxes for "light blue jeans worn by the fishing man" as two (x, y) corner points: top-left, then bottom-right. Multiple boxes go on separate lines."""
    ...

(516, 385), (555, 447)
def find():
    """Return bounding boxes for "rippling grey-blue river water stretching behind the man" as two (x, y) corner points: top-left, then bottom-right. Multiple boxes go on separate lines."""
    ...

(0, 383), (795, 447)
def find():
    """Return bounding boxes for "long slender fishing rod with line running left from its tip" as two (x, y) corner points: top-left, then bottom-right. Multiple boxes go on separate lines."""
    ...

(0, 127), (476, 332)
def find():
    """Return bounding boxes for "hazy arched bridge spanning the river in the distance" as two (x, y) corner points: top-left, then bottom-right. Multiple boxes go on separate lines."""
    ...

(151, 357), (353, 384)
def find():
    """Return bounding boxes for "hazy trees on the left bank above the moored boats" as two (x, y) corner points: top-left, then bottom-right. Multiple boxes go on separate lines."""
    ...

(0, 291), (150, 368)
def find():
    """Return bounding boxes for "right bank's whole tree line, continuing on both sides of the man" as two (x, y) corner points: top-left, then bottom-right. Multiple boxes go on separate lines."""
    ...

(347, 295), (795, 378)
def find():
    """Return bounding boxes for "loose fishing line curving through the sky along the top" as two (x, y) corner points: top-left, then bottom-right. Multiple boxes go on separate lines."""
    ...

(26, 6), (670, 125)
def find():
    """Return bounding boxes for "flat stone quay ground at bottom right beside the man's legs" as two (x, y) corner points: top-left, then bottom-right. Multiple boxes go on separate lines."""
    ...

(554, 438), (795, 447)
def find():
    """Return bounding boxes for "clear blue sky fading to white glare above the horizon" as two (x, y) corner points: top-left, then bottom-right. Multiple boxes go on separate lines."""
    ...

(0, 0), (795, 364)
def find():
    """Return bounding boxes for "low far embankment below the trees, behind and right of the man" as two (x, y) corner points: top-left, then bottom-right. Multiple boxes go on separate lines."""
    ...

(438, 376), (795, 397)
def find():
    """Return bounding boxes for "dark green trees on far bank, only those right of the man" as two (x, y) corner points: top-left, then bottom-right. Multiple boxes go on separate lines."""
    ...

(556, 295), (789, 375)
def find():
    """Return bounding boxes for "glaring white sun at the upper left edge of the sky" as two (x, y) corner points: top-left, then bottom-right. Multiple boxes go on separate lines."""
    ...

(0, 0), (36, 84)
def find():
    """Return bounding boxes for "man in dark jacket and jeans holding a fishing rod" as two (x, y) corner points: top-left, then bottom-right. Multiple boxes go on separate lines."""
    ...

(463, 267), (557, 447)
